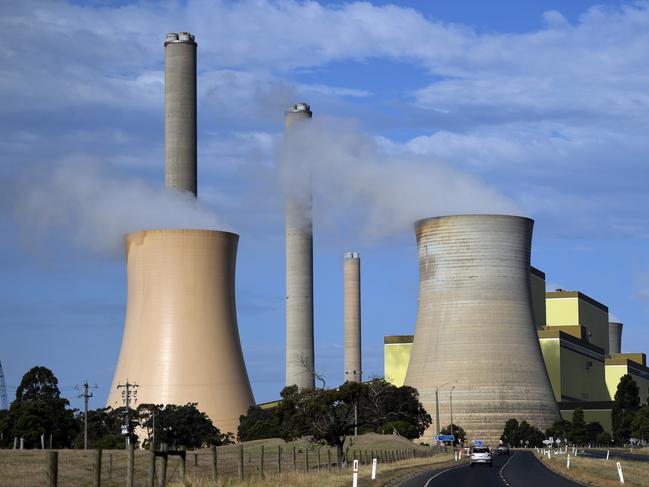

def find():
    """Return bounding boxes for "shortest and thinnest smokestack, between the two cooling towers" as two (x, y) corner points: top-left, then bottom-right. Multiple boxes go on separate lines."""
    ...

(343, 252), (362, 382)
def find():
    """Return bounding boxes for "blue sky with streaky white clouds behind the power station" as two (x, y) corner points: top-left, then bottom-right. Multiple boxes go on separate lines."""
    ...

(0, 0), (649, 414)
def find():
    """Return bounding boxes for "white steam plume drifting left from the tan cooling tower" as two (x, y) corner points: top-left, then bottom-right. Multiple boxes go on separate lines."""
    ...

(14, 156), (224, 255)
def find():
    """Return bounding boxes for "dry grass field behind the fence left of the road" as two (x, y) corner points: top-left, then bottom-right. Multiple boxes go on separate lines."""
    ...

(0, 434), (449, 487)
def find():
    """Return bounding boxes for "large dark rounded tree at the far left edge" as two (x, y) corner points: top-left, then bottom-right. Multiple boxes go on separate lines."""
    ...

(0, 367), (77, 448)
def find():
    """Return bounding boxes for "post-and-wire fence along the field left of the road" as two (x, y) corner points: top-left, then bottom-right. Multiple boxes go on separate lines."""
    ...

(0, 445), (432, 487)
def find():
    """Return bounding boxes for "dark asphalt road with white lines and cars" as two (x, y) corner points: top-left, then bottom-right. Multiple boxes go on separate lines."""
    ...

(402, 451), (581, 487)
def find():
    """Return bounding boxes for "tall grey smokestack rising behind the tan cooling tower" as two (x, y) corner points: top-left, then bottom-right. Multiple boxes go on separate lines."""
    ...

(164, 32), (197, 196)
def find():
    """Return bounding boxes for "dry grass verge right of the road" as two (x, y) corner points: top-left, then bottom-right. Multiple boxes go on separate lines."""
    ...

(543, 455), (649, 487)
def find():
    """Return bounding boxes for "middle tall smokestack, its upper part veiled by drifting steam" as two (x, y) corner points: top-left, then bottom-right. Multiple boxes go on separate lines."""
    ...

(284, 103), (315, 388)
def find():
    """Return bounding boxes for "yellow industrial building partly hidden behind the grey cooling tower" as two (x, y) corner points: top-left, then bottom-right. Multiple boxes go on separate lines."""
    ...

(384, 267), (649, 432)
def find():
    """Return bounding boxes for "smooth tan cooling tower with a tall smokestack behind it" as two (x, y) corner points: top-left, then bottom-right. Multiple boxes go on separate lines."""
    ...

(108, 230), (254, 434)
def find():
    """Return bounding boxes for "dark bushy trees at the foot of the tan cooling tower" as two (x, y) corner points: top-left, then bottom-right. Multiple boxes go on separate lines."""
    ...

(137, 403), (227, 448)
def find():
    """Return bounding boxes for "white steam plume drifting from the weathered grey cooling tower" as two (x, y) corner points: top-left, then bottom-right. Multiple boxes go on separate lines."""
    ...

(279, 117), (521, 238)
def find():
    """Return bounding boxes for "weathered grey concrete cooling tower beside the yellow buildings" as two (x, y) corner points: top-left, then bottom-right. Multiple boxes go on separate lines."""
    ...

(405, 215), (560, 444)
